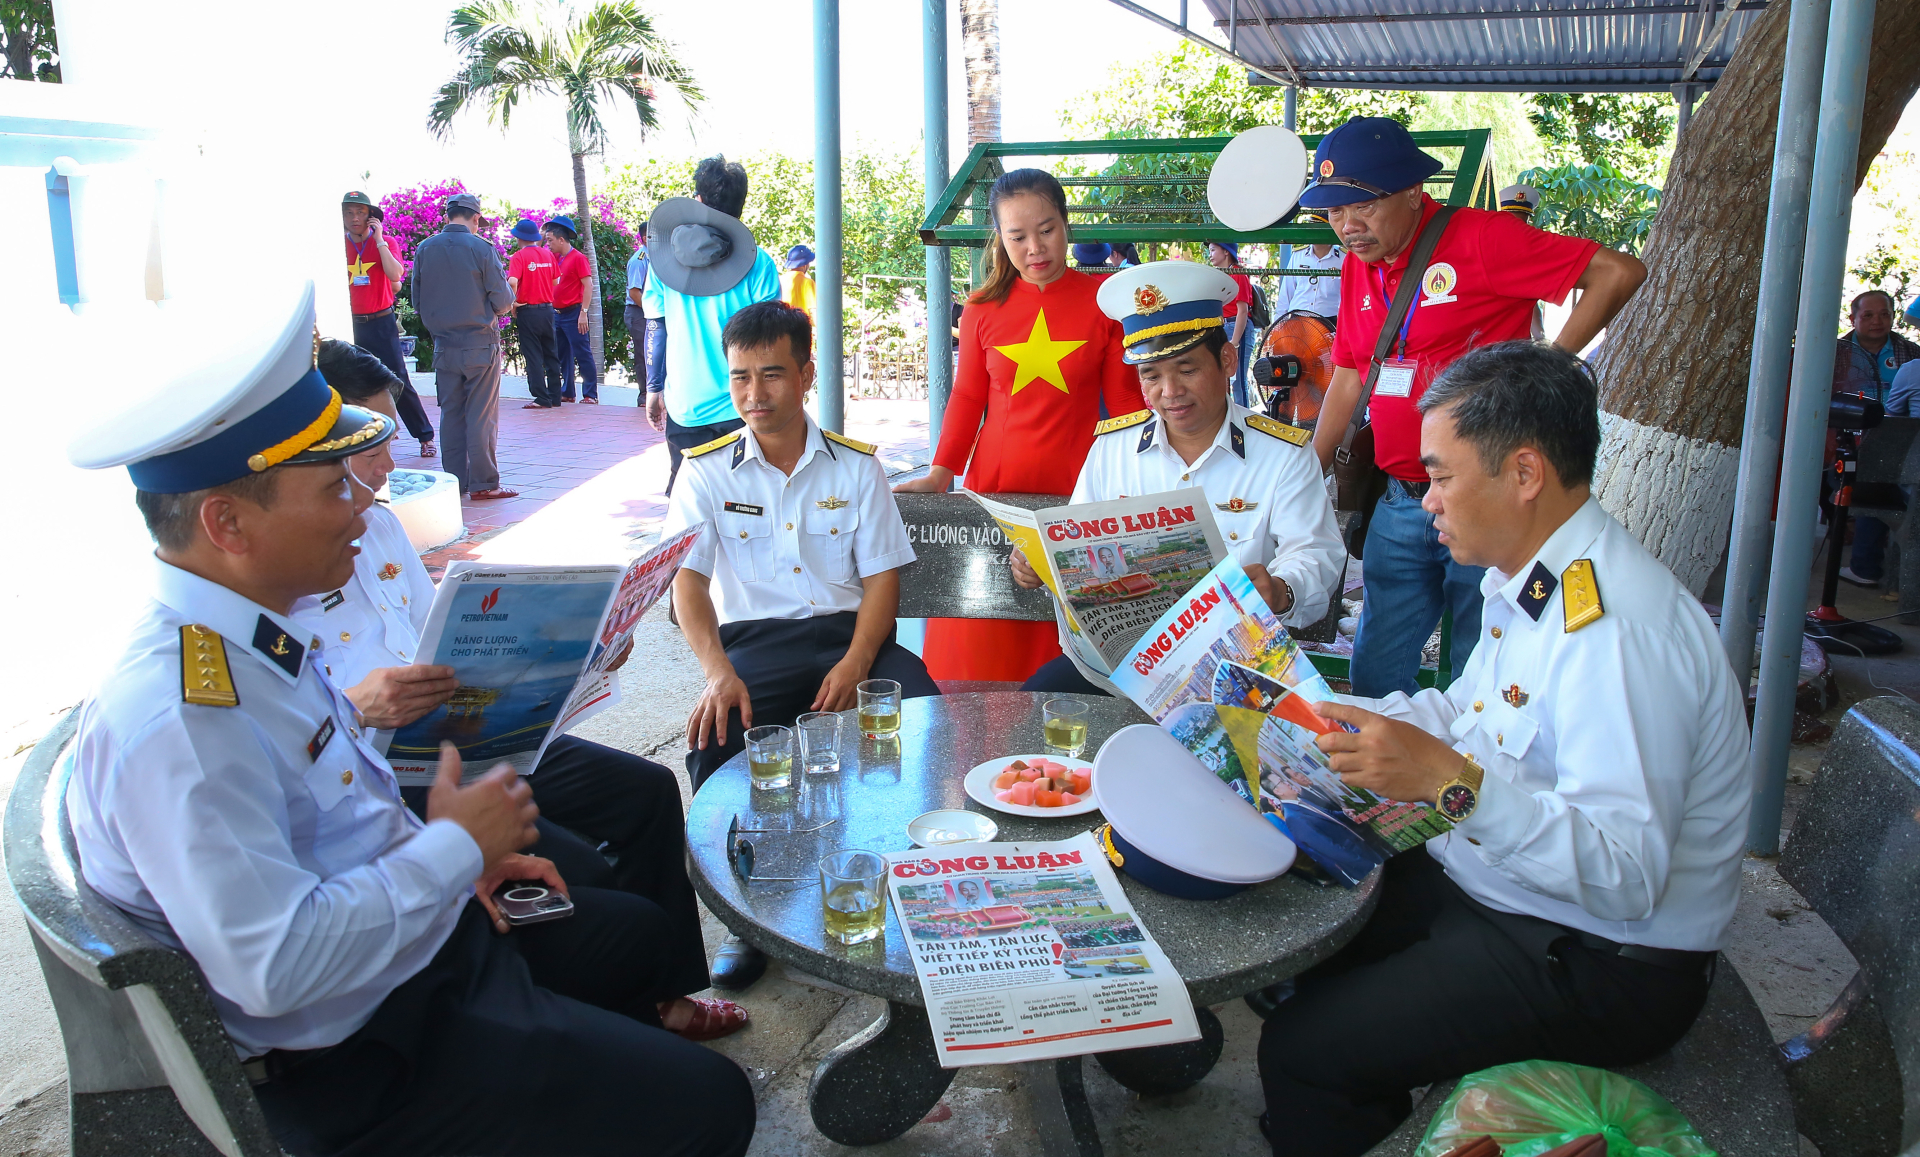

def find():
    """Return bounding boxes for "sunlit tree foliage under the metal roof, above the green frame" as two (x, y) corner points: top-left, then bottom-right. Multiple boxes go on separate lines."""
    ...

(1060, 40), (1428, 140)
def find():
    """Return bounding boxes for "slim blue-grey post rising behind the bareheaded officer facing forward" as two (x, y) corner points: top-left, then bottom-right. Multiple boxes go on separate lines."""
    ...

(814, 0), (847, 434)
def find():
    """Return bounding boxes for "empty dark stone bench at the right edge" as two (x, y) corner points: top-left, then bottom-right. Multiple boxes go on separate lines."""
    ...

(1780, 690), (1920, 1157)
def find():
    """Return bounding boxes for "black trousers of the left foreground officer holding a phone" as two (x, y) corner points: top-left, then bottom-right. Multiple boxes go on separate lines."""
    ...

(255, 888), (755, 1157)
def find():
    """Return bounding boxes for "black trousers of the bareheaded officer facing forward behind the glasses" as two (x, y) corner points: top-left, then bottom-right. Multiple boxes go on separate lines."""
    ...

(687, 610), (941, 791)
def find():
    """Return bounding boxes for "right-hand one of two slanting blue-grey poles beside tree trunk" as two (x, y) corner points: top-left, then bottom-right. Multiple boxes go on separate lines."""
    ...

(1747, 0), (1874, 856)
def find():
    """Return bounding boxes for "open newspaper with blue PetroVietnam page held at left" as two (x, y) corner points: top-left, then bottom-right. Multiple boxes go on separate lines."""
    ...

(374, 526), (703, 785)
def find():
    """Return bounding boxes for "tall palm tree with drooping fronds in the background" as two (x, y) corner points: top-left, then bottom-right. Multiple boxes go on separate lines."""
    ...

(426, 0), (705, 370)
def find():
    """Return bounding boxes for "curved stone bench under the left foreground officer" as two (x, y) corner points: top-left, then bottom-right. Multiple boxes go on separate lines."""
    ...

(4, 712), (280, 1157)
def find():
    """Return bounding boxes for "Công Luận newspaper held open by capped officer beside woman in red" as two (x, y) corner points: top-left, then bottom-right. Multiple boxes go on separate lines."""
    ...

(966, 485), (1227, 691)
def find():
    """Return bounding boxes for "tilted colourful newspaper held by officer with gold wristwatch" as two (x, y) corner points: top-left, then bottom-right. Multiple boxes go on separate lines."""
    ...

(1114, 562), (1453, 885)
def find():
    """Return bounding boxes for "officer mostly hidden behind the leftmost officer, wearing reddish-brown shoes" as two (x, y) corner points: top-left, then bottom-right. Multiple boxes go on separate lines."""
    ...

(294, 340), (747, 1040)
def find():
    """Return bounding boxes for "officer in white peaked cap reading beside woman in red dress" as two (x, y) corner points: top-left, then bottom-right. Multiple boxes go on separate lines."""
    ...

(1010, 261), (1346, 695)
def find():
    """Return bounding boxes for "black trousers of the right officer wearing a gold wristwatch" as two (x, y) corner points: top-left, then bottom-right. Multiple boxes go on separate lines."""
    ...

(1260, 848), (1711, 1157)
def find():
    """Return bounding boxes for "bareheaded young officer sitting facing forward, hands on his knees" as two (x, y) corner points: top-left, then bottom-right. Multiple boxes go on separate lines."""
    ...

(660, 301), (941, 988)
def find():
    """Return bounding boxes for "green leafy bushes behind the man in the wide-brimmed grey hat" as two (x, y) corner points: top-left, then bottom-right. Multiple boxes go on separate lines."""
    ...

(607, 150), (925, 307)
